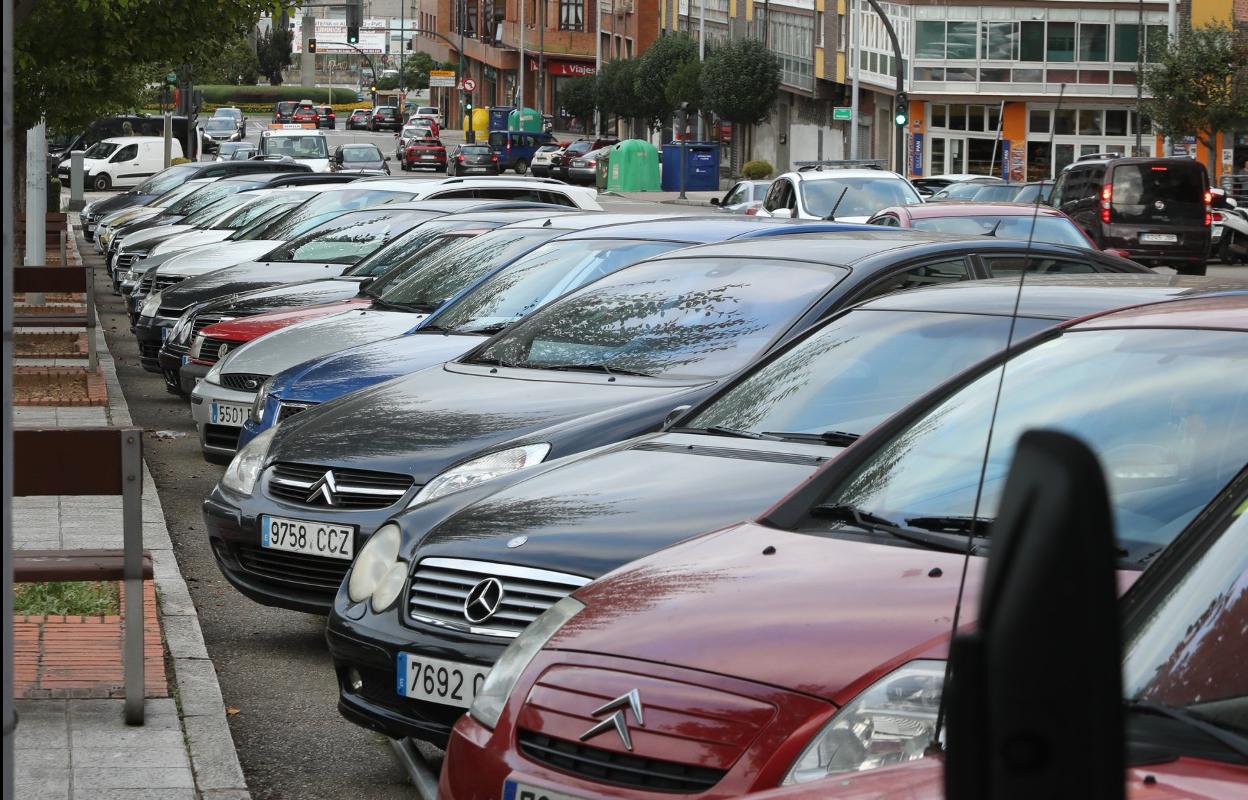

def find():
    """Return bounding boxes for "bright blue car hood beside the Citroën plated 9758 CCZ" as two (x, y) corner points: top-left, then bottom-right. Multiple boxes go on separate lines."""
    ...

(273, 332), (484, 403)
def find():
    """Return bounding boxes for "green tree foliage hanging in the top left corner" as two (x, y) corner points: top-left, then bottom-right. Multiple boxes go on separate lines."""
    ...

(14, 0), (273, 131)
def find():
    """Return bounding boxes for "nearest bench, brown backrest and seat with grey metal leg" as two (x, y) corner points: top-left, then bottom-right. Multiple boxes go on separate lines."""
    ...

(12, 427), (152, 725)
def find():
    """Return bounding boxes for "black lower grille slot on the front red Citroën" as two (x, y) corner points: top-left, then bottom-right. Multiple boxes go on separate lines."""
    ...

(517, 729), (724, 794)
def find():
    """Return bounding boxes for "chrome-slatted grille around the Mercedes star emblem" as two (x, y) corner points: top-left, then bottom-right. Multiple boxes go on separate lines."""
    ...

(408, 558), (589, 638)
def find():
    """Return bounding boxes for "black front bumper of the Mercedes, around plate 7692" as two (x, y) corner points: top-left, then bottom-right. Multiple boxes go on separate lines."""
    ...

(326, 587), (510, 748)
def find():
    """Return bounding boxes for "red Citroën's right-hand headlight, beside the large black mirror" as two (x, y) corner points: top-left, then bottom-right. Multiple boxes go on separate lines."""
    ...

(784, 660), (945, 785)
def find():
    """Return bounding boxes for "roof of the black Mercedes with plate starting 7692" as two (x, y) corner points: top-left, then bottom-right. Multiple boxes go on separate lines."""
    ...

(860, 273), (1248, 320)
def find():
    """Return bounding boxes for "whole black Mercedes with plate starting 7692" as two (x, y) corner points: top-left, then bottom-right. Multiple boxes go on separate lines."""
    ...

(327, 275), (1228, 744)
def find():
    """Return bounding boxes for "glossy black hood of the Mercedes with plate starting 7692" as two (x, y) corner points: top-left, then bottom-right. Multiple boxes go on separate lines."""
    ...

(419, 433), (841, 578)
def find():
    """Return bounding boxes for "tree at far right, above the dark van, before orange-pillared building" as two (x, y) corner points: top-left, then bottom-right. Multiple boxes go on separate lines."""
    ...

(1144, 24), (1248, 175)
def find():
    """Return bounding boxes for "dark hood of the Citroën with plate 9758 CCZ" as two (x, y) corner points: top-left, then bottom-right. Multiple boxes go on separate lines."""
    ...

(270, 362), (689, 484)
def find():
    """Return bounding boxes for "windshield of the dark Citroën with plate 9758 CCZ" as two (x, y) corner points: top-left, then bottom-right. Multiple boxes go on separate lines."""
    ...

(472, 257), (845, 379)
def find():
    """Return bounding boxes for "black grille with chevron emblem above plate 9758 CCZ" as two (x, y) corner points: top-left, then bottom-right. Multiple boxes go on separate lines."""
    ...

(268, 462), (413, 510)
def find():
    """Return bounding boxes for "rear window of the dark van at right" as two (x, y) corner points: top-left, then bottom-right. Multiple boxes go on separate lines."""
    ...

(1109, 163), (1208, 225)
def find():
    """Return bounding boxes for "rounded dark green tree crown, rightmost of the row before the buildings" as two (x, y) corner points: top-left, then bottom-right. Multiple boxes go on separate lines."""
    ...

(701, 39), (780, 125)
